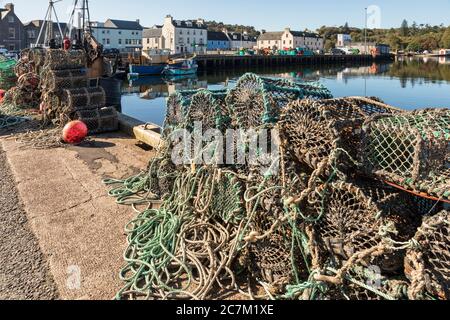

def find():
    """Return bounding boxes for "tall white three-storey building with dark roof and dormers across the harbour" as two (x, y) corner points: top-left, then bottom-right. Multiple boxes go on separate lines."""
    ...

(158, 15), (208, 54)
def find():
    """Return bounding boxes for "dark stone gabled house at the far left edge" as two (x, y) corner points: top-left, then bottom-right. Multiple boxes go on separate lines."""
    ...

(0, 3), (26, 51)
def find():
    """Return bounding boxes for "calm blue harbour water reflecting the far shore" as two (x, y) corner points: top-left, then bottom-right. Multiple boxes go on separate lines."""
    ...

(118, 57), (450, 125)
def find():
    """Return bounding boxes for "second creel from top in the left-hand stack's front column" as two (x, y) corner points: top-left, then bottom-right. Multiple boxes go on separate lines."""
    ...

(41, 69), (88, 91)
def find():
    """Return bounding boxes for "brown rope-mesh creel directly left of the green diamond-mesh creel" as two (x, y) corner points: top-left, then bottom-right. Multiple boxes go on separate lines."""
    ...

(280, 98), (395, 175)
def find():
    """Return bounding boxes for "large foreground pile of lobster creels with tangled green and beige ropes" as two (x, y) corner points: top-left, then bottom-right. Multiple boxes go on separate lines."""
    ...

(105, 74), (450, 300)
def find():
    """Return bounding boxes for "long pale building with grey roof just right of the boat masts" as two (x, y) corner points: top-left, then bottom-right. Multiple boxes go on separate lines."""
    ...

(91, 19), (144, 52)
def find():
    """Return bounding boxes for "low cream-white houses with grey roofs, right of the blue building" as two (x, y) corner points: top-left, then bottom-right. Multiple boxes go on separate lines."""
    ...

(257, 28), (324, 50)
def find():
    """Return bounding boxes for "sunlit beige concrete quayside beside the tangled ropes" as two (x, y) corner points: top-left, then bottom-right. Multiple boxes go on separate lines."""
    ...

(0, 135), (153, 299)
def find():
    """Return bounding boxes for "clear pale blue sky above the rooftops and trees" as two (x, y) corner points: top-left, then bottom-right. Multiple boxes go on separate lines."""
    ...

(4, 0), (450, 31)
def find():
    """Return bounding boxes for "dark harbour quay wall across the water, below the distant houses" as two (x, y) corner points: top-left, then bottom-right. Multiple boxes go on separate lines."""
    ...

(196, 55), (392, 71)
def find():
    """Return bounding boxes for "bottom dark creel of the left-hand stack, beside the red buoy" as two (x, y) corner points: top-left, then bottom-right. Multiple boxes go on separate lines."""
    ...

(75, 108), (119, 134)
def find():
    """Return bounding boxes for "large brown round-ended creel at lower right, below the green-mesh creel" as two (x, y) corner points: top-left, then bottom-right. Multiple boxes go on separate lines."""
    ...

(306, 182), (420, 275)
